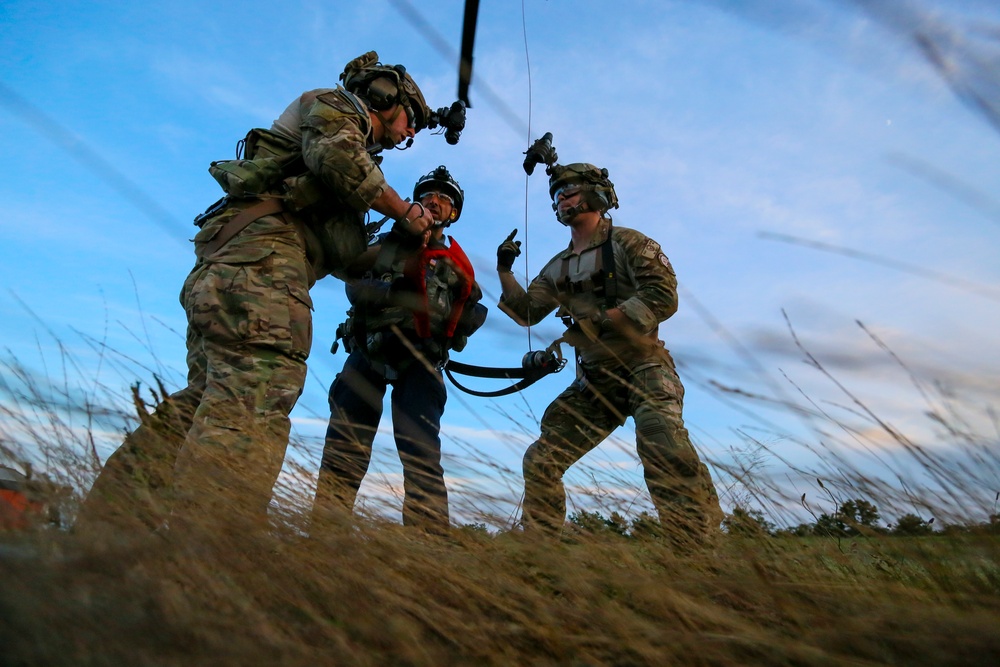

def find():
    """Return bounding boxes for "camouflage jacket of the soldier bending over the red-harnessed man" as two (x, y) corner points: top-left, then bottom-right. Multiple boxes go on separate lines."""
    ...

(195, 87), (388, 283)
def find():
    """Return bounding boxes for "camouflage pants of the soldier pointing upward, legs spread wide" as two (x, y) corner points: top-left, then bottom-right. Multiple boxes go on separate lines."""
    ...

(523, 357), (722, 541)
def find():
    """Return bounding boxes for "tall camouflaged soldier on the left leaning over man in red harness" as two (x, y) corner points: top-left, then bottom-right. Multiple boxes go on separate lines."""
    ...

(80, 51), (448, 526)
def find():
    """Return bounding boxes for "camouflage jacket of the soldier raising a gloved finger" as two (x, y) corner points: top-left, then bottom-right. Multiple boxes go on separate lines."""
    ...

(500, 219), (677, 364)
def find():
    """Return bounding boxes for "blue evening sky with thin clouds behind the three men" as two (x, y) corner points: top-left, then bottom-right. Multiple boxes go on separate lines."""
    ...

(0, 0), (1000, 532)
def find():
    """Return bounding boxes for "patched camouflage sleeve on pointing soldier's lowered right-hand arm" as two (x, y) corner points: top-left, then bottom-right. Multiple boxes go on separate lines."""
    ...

(615, 229), (677, 331)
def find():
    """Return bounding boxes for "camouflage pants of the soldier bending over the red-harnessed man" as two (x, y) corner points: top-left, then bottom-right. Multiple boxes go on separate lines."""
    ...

(82, 236), (312, 536)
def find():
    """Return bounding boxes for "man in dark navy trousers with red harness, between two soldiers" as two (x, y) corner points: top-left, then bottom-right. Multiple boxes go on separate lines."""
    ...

(313, 166), (486, 533)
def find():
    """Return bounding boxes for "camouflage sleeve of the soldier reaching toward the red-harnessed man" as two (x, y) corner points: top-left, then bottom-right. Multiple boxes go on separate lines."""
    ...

(302, 92), (388, 211)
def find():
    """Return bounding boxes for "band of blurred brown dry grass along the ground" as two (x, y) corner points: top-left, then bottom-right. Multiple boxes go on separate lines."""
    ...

(0, 508), (1000, 665)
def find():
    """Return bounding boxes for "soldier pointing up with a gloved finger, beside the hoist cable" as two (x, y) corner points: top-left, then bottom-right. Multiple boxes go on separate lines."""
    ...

(497, 163), (722, 542)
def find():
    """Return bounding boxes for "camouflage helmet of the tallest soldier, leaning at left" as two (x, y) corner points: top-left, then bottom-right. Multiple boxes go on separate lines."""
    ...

(340, 51), (431, 132)
